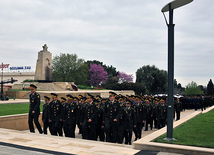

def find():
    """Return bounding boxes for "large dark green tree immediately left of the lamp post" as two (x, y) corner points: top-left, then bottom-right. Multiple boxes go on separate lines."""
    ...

(136, 65), (167, 94)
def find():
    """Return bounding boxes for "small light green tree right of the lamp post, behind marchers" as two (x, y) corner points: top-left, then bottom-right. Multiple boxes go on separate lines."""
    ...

(184, 81), (203, 95)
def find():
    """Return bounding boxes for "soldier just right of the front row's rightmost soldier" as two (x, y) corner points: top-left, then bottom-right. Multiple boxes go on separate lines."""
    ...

(133, 96), (145, 141)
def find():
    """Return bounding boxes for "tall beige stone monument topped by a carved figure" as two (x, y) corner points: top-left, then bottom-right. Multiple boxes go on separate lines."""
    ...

(35, 44), (52, 82)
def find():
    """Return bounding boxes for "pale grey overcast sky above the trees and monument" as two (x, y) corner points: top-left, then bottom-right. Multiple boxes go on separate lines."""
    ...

(0, 0), (214, 86)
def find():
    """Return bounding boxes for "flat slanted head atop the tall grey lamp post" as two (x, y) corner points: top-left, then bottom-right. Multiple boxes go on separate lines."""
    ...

(161, 0), (193, 12)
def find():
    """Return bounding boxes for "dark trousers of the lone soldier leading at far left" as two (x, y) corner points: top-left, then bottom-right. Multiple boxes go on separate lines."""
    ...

(28, 113), (42, 134)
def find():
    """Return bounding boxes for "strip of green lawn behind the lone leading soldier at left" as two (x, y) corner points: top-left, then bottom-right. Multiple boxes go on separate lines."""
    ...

(0, 104), (42, 116)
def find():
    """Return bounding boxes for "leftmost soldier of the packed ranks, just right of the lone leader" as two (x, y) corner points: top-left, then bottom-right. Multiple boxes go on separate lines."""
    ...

(42, 96), (51, 134)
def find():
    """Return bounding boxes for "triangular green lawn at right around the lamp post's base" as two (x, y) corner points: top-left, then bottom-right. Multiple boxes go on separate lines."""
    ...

(154, 110), (214, 148)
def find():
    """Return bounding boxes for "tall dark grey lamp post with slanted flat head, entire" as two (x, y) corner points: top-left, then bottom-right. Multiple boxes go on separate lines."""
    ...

(161, 0), (193, 140)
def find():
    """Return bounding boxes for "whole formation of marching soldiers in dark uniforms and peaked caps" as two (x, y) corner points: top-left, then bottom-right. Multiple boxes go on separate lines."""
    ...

(29, 85), (213, 145)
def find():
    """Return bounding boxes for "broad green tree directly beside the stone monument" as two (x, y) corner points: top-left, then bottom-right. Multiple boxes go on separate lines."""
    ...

(52, 53), (89, 84)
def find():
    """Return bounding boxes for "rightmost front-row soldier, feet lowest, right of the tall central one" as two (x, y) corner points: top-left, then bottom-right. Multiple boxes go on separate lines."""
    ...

(124, 100), (136, 145)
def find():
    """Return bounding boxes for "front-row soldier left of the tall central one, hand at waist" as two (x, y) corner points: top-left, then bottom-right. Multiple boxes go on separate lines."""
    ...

(82, 93), (98, 140)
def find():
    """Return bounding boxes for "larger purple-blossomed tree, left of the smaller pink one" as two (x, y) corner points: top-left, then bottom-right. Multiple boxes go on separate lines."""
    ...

(89, 64), (108, 86)
